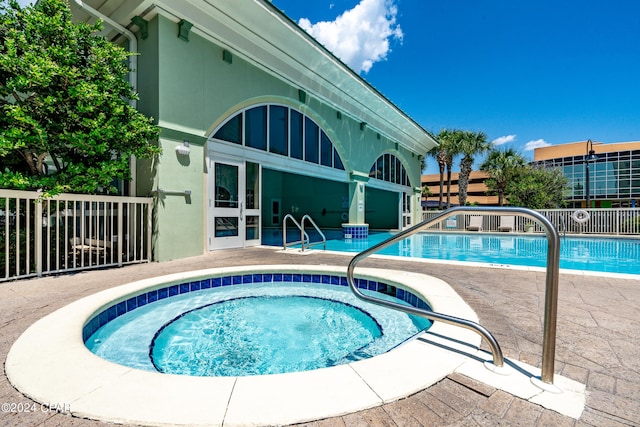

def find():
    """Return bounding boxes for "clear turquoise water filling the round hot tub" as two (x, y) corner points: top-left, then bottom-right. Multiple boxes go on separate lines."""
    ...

(85, 282), (431, 376)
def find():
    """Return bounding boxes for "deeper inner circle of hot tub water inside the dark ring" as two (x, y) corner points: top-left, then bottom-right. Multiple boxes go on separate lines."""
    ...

(151, 296), (382, 376)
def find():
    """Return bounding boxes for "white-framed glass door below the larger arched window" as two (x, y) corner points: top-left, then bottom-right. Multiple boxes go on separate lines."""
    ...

(207, 154), (261, 250)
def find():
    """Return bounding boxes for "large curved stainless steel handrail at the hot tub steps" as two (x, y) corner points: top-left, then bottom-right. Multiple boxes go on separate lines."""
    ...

(347, 206), (560, 384)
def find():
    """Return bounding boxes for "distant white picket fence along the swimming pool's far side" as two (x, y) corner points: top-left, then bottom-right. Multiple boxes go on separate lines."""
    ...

(422, 208), (640, 235)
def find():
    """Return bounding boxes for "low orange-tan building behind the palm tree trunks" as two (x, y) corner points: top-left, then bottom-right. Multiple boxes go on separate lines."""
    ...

(422, 171), (498, 209)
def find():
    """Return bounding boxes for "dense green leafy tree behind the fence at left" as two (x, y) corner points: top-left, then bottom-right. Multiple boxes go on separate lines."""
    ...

(0, 0), (159, 194)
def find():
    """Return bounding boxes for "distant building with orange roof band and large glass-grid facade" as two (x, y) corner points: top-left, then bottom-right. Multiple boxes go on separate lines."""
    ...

(532, 141), (640, 208)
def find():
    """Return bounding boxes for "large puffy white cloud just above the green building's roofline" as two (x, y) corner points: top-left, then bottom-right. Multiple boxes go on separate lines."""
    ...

(298, 0), (403, 73)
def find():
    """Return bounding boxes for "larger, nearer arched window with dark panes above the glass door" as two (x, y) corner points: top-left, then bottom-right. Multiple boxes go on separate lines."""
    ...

(213, 104), (344, 170)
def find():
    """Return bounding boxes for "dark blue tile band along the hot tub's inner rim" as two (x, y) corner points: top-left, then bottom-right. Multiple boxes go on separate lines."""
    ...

(82, 273), (430, 342)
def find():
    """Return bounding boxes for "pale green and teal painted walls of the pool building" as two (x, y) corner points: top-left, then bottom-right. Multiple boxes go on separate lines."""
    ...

(132, 15), (423, 260)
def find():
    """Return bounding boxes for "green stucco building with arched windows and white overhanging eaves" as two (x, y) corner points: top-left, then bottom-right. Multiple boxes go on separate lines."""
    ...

(70, 0), (435, 260)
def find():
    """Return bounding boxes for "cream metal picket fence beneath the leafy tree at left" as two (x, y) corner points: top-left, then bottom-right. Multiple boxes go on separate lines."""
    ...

(0, 190), (153, 282)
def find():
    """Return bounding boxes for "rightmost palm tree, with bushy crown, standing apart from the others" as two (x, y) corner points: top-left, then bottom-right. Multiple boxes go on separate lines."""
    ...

(480, 148), (527, 206)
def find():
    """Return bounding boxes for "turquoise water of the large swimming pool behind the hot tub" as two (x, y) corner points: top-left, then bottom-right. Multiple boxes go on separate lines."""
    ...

(263, 231), (640, 274)
